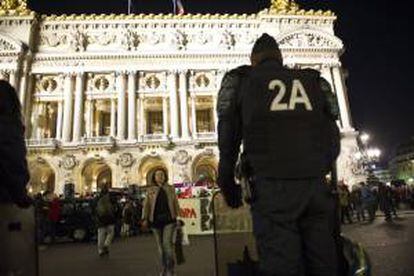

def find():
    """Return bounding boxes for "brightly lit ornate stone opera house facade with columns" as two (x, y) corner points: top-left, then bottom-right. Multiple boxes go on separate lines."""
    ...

(0, 0), (357, 194)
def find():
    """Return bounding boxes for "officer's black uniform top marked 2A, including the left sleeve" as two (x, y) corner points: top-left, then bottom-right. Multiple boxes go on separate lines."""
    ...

(217, 59), (340, 179)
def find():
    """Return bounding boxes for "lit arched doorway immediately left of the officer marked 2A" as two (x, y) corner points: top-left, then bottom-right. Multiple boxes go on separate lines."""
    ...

(193, 155), (217, 186)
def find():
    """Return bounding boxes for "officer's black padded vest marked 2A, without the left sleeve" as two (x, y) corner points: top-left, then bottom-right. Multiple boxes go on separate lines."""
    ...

(241, 59), (340, 179)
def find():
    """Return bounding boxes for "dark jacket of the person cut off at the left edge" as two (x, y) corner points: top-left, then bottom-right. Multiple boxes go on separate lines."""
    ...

(0, 116), (30, 203)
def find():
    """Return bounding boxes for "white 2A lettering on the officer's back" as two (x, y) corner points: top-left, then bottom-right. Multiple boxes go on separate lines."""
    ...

(269, 80), (313, 111)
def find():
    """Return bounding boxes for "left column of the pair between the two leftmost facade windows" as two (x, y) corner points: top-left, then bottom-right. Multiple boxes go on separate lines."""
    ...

(62, 74), (73, 142)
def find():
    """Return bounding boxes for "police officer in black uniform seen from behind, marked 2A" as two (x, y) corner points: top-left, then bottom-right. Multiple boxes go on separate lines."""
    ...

(217, 34), (340, 276)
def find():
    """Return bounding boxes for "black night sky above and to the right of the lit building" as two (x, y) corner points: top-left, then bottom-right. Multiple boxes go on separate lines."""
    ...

(29, 0), (414, 161)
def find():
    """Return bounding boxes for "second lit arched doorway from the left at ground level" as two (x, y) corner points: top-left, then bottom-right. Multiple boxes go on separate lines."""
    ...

(81, 161), (112, 193)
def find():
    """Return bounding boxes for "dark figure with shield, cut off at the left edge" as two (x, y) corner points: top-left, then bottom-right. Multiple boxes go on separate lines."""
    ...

(0, 80), (36, 275)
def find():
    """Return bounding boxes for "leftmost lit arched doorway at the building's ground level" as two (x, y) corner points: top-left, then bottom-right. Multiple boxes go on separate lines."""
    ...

(28, 160), (56, 195)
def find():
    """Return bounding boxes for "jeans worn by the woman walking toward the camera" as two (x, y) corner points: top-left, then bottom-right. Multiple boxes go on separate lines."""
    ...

(152, 223), (176, 273)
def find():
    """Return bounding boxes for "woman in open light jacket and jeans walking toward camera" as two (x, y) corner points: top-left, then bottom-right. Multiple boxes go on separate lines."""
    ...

(142, 169), (180, 276)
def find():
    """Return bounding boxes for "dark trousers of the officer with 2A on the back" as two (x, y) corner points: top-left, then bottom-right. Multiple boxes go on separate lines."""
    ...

(251, 178), (337, 276)
